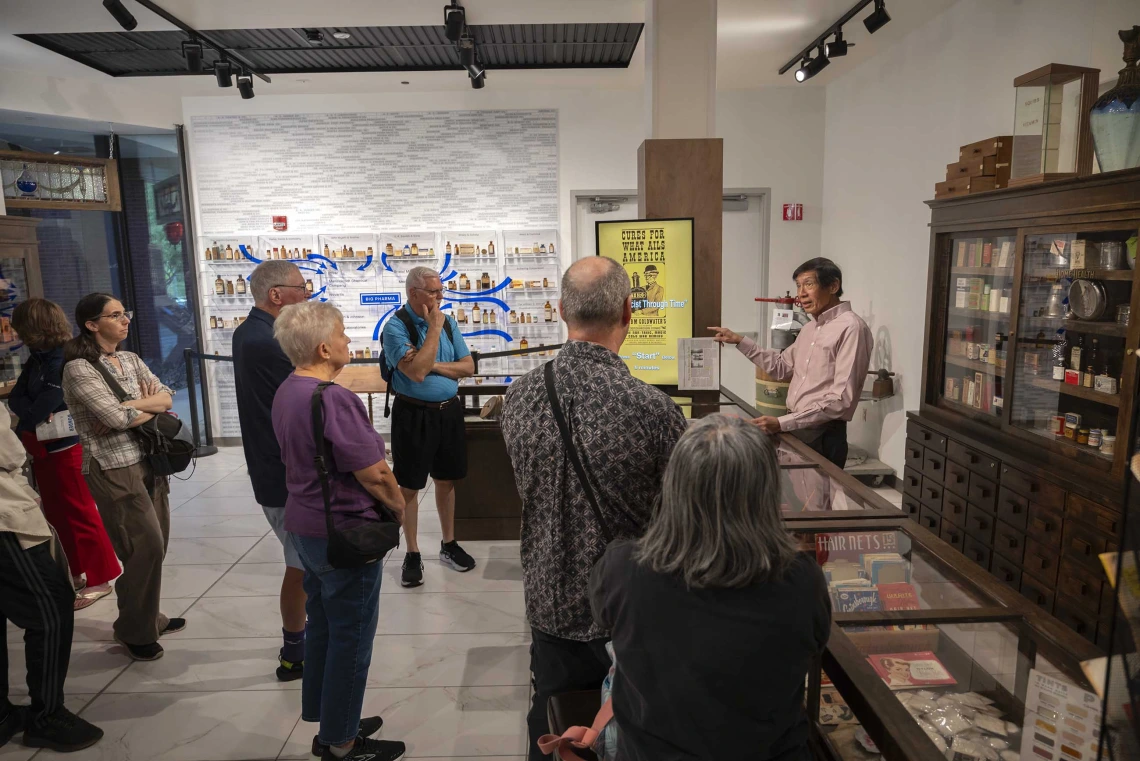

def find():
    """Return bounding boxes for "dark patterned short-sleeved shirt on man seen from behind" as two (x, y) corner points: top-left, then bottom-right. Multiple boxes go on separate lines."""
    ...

(502, 341), (686, 641)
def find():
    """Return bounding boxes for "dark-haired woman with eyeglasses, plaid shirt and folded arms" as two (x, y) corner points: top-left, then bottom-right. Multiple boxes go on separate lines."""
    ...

(63, 293), (186, 661)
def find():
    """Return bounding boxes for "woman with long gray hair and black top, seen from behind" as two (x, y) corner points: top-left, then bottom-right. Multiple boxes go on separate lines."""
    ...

(591, 415), (831, 761)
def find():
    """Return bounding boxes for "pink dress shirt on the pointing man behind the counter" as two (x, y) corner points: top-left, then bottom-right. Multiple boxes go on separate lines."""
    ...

(736, 301), (874, 431)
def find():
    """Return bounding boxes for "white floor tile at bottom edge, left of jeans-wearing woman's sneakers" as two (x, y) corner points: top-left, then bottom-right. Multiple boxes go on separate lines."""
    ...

(36, 692), (301, 761)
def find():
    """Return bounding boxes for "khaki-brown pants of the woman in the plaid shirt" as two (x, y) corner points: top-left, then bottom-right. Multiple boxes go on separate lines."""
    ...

(87, 457), (170, 645)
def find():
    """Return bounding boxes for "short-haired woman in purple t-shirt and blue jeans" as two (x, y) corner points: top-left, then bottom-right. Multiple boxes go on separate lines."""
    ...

(272, 302), (405, 761)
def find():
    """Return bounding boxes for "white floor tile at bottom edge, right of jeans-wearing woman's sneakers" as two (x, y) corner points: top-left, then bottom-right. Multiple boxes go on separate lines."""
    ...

(280, 687), (529, 759)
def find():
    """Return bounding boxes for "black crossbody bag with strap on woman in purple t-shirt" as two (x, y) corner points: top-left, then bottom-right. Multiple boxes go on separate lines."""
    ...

(310, 383), (400, 568)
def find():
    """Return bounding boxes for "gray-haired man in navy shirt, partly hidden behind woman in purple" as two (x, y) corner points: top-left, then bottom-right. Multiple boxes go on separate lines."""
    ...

(234, 261), (306, 681)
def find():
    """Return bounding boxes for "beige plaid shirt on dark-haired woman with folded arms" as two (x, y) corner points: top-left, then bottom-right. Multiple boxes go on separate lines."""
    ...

(64, 351), (174, 473)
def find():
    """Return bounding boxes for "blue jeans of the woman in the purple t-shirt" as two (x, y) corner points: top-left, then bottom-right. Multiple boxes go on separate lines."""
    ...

(288, 533), (384, 745)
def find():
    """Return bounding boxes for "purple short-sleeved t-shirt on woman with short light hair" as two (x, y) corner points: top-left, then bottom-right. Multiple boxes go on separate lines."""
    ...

(272, 374), (384, 537)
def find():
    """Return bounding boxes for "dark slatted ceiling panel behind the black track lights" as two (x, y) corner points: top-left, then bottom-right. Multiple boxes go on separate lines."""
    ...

(17, 24), (643, 76)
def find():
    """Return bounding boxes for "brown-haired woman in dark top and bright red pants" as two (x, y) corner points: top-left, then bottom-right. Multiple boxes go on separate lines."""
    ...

(8, 298), (120, 609)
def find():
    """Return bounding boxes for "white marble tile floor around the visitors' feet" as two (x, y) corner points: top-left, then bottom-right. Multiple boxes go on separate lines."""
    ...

(0, 449), (530, 761)
